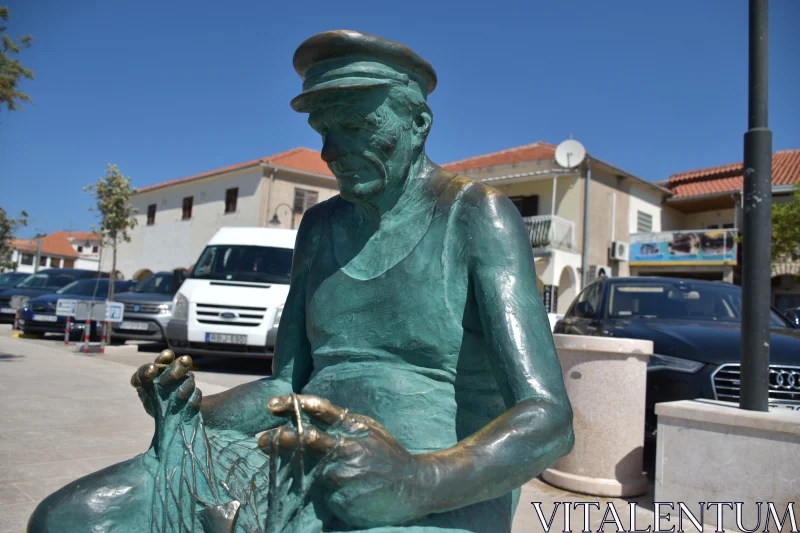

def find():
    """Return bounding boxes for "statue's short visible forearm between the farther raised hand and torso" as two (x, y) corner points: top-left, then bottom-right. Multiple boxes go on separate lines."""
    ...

(200, 378), (292, 435)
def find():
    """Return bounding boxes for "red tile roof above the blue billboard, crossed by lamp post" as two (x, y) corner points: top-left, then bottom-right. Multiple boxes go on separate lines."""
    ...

(667, 149), (800, 198)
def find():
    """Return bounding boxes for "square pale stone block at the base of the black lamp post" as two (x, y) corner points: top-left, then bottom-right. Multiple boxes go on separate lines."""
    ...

(655, 400), (800, 532)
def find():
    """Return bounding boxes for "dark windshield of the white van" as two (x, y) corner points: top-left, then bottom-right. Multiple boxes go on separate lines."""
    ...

(191, 244), (293, 284)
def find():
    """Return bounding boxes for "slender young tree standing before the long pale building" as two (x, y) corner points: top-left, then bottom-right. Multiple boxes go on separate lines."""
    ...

(83, 164), (137, 338)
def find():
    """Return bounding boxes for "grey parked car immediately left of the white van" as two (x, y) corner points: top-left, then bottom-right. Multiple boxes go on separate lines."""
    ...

(111, 270), (186, 343)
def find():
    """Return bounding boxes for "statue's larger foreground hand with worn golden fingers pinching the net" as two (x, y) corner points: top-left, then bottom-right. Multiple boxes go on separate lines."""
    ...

(259, 395), (426, 527)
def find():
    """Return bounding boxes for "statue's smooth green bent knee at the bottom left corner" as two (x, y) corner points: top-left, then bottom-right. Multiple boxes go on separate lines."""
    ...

(28, 458), (149, 533)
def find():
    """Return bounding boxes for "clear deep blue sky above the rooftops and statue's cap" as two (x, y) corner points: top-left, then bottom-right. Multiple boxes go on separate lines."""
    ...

(0, 0), (800, 236)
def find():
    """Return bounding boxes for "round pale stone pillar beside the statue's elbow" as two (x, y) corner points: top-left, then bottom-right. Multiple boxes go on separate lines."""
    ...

(542, 334), (653, 497)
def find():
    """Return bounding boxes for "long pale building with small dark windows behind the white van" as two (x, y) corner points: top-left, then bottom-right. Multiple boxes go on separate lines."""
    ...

(112, 148), (339, 279)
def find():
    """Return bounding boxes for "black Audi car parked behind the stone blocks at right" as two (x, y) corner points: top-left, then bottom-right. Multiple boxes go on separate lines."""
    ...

(553, 277), (800, 438)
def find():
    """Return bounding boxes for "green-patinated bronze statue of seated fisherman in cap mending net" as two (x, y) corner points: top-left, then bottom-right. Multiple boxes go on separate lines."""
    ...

(29, 31), (573, 533)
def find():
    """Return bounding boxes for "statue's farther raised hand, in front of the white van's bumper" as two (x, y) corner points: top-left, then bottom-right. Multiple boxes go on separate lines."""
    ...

(131, 350), (202, 428)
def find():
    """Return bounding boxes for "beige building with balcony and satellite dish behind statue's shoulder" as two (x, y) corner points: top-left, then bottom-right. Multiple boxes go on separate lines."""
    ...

(444, 142), (669, 313)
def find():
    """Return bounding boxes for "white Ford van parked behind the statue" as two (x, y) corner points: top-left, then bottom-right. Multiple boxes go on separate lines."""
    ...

(167, 227), (297, 357)
